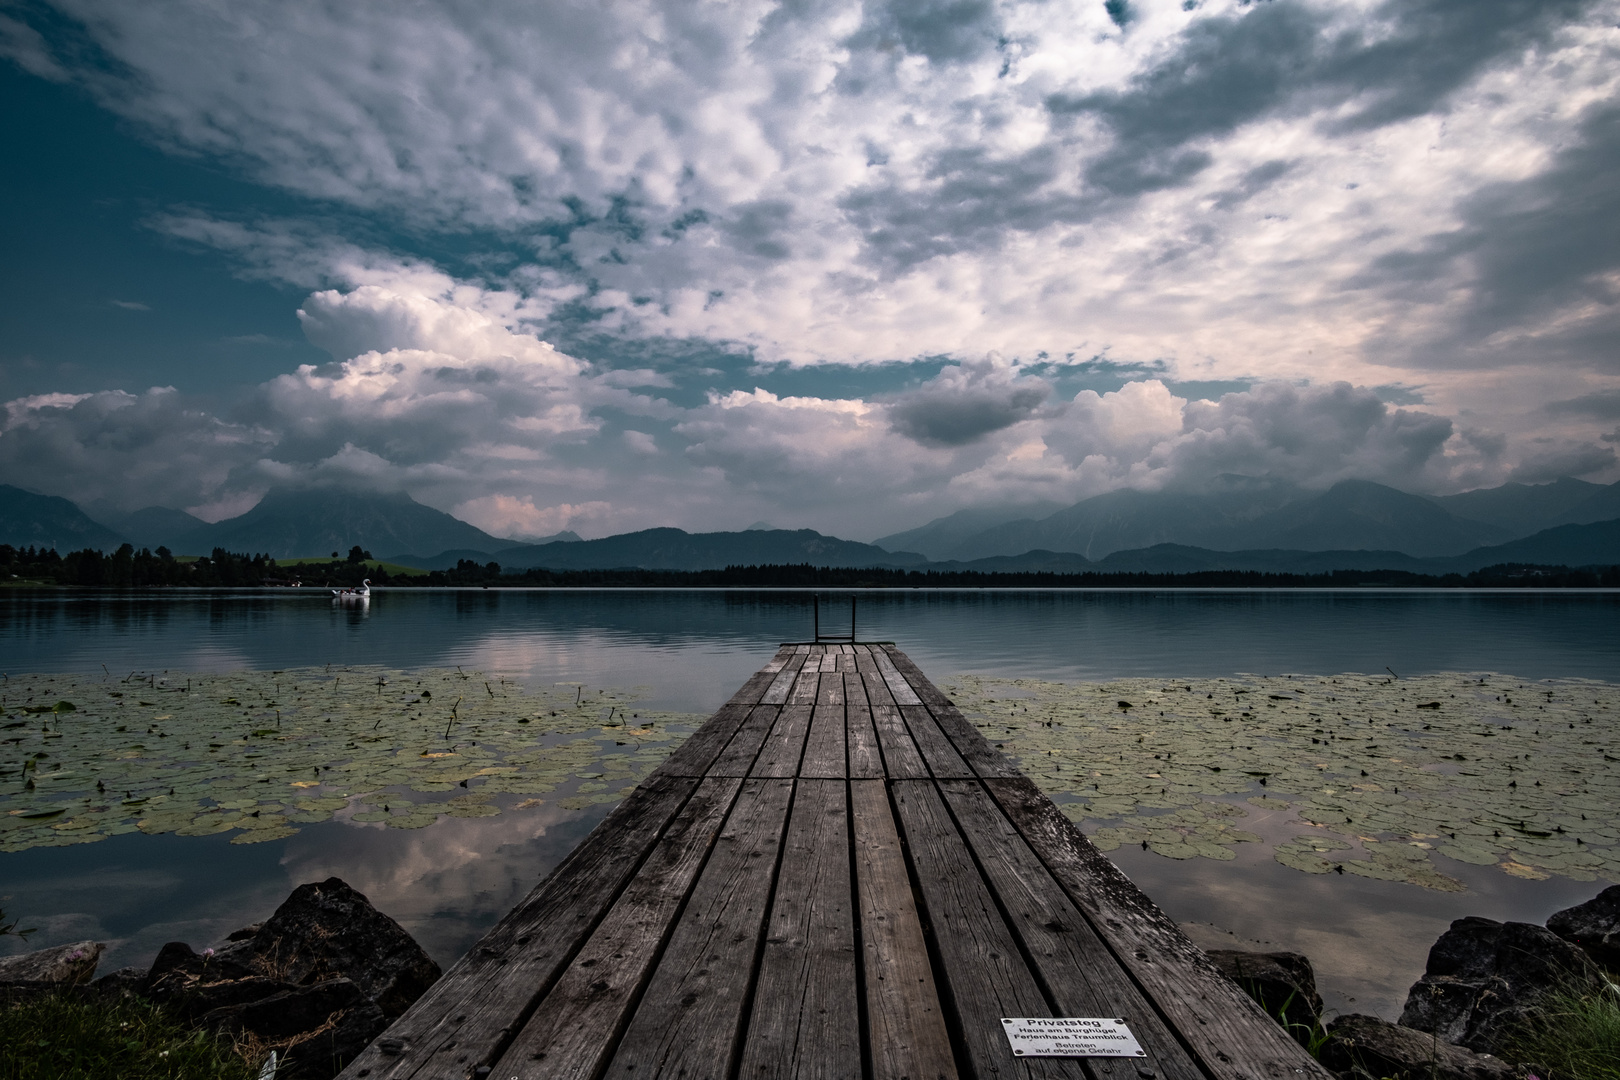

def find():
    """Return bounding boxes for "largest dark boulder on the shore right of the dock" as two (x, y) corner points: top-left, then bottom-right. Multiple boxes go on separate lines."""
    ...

(1400, 916), (1597, 1054)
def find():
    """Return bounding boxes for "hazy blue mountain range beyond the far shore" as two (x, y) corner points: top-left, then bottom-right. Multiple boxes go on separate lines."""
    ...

(0, 476), (1620, 573)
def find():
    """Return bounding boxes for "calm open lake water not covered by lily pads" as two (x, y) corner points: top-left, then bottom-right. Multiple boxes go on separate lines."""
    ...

(0, 589), (1620, 1017)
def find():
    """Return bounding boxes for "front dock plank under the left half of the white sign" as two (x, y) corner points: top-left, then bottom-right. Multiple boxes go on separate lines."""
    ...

(891, 780), (1085, 1080)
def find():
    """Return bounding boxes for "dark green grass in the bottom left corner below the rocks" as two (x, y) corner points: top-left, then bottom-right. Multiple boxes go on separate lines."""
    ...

(0, 994), (258, 1080)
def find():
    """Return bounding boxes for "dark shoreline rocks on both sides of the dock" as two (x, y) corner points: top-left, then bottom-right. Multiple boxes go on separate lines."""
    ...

(0, 878), (1620, 1080)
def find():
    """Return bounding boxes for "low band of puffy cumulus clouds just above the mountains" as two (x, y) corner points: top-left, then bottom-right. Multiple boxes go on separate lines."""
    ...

(0, 260), (1614, 536)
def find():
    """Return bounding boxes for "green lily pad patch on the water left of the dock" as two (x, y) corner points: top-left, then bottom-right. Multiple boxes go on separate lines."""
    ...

(0, 667), (705, 852)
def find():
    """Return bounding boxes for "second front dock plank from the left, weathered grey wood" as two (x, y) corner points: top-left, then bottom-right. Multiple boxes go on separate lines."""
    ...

(494, 779), (742, 1080)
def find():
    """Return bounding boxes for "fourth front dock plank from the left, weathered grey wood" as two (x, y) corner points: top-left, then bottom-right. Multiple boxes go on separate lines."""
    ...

(737, 779), (860, 1080)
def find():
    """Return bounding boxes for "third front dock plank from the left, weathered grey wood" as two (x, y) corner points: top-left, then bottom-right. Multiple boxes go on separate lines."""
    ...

(606, 779), (794, 1080)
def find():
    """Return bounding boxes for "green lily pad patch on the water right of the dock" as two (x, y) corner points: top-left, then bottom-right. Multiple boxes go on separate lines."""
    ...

(951, 672), (1620, 891)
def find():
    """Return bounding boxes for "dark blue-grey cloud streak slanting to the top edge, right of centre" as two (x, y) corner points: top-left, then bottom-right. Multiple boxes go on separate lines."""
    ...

(841, 0), (1591, 269)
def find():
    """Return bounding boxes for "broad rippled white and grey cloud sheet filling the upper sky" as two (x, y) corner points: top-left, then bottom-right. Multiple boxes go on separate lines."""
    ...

(8, 0), (1620, 404)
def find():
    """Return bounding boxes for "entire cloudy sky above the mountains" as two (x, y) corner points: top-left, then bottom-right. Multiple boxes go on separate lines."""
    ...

(0, 0), (1620, 539)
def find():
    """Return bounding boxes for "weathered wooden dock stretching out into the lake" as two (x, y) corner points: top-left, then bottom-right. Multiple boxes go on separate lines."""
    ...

(342, 644), (1328, 1080)
